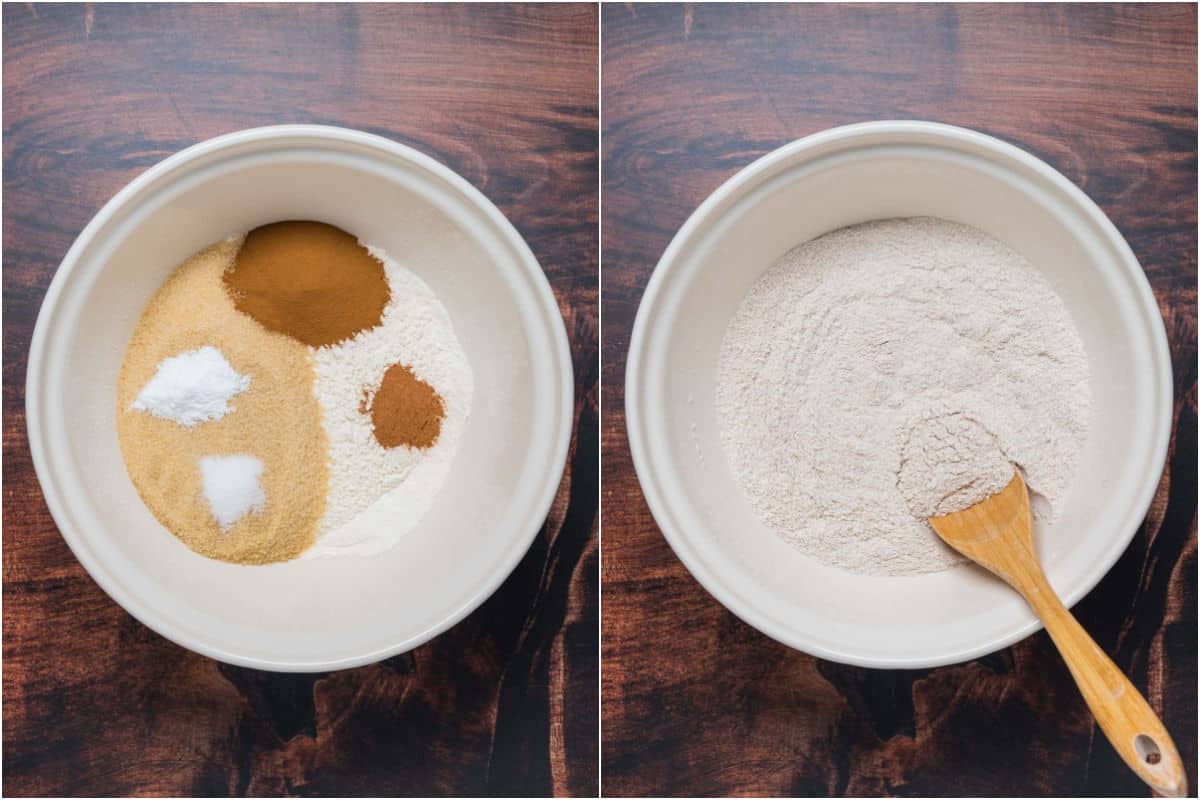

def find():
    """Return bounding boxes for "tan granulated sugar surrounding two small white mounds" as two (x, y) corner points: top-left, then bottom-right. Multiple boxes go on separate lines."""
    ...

(116, 240), (329, 564)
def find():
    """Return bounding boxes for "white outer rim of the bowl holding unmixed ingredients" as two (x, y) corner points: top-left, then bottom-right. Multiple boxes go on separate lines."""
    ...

(25, 125), (575, 672)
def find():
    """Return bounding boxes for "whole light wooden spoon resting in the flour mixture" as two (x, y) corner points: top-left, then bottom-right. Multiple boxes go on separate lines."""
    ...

(929, 470), (1188, 798)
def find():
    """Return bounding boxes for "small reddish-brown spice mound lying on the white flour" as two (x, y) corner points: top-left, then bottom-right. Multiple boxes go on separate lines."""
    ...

(359, 363), (446, 450)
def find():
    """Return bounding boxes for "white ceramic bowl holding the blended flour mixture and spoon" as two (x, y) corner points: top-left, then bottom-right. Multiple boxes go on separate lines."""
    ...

(625, 122), (1171, 668)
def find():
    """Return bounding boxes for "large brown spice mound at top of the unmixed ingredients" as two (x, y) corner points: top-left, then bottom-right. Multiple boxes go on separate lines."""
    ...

(223, 221), (391, 347)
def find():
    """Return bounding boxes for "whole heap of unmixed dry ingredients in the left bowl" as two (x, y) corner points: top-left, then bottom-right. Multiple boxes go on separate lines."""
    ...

(118, 221), (472, 564)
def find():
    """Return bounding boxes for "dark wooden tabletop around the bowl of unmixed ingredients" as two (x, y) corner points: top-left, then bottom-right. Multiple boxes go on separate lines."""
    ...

(4, 4), (599, 795)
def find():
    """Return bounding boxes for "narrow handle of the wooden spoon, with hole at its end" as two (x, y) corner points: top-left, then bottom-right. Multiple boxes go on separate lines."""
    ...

(1016, 570), (1188, 798)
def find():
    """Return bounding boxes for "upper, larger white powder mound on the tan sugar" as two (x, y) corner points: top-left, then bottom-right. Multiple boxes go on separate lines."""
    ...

(130, 347), (250, 428)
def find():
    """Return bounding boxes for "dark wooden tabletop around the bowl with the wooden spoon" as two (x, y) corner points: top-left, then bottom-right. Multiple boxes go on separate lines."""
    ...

(601, 5), (1200, 795)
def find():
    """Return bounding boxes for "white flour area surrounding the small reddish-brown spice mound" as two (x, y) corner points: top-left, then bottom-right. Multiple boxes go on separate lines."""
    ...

(305, 246), (474, 557)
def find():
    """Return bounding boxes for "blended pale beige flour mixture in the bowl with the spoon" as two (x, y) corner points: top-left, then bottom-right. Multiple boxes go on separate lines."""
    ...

(716, 217), (1091, 575)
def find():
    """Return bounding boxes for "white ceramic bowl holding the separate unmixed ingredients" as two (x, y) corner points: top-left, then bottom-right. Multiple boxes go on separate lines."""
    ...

(25, 126), (572, 672)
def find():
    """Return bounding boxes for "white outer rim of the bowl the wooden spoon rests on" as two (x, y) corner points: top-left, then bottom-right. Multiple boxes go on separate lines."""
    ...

(624, 120), (1175, 669)
